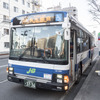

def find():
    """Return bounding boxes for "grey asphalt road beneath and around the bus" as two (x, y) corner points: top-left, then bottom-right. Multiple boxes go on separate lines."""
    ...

(0, 55), (96, 100)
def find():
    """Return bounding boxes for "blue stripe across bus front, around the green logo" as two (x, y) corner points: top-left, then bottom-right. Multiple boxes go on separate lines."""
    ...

(12, 65), (69, 77)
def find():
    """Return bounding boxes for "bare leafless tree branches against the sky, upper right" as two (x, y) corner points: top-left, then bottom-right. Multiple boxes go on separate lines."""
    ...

(88, 0), (100, 24)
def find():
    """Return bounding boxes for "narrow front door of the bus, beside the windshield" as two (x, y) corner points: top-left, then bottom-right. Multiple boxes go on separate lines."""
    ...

(69, 30), (77, 83)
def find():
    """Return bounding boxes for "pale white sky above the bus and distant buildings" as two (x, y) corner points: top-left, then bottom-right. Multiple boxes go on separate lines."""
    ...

(41, 0), (100, 33)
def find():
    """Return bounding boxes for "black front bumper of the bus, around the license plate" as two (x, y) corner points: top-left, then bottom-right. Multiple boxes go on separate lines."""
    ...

(7, 74), (68, 91)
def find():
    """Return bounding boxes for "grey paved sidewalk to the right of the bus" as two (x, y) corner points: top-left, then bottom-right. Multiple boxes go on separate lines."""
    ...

(74, 57), (100, 100)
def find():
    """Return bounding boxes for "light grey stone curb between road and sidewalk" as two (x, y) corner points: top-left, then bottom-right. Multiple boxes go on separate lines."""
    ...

(74, 57), (100, 100)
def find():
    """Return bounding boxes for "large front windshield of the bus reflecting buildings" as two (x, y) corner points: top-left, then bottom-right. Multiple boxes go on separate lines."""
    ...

(10, 25), (68, 63)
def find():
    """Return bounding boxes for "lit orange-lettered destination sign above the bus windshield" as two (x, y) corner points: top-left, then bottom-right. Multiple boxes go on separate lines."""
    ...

(13, 13), (63, 25)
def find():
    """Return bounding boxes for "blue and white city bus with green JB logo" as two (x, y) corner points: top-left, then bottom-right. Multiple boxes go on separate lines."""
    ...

(7, 11), (94, 91)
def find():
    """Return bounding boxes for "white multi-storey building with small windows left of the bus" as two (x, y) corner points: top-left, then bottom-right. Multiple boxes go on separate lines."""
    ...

(0, 0), (39, 52)
